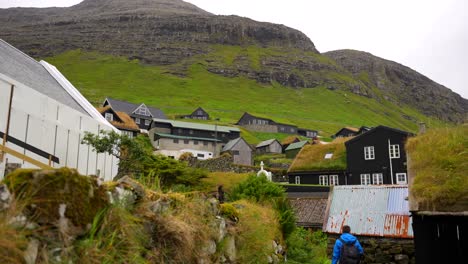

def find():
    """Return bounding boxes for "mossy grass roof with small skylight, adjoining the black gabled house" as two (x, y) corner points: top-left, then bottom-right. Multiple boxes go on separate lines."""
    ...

(289, 138), (348, 172)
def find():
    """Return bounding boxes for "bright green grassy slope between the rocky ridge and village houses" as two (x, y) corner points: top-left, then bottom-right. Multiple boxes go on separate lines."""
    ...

(47, 47), (442, 143)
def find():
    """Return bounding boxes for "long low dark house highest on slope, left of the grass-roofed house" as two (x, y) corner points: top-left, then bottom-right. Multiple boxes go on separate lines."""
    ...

(236, 112), (317, 138)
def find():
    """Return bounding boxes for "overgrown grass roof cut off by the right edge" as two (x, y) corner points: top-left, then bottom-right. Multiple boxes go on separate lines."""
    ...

(406, 124), (468, 212)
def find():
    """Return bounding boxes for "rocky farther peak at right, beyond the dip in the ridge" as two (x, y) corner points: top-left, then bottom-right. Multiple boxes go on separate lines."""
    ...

(325, 50), (468, 122)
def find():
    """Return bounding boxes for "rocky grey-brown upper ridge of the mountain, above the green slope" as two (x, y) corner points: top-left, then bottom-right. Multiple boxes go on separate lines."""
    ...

(0, 0), (468, 122)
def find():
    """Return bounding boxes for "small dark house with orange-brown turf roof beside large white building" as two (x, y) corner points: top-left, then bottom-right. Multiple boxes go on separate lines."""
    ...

(97, 105), (140, 137)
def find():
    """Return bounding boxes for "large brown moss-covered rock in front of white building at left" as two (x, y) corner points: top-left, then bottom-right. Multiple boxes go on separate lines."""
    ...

(5, 168), (108, 227)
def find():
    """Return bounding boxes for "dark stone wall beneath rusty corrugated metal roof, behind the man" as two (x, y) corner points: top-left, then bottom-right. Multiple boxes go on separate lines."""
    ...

(327, 234), (416, 264)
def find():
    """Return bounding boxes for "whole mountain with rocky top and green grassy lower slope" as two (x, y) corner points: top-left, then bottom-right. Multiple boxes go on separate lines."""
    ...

(0, 0), (468, 142)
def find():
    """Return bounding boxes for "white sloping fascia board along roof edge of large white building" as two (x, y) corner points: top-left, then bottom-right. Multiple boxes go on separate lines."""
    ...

(40, 60), (120, 134)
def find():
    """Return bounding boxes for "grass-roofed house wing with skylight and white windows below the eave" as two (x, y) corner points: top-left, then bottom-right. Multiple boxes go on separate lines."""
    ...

(288, 140), (347, 186)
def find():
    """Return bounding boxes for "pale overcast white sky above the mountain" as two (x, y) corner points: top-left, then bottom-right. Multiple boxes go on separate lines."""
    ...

(0, 0), (468, 98)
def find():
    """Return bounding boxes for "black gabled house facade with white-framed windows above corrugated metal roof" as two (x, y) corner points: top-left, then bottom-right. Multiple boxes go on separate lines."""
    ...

(345, 126), (411, 185)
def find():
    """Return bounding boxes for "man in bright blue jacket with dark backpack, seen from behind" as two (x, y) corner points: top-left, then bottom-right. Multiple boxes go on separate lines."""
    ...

(332, 226), (364, 264)
